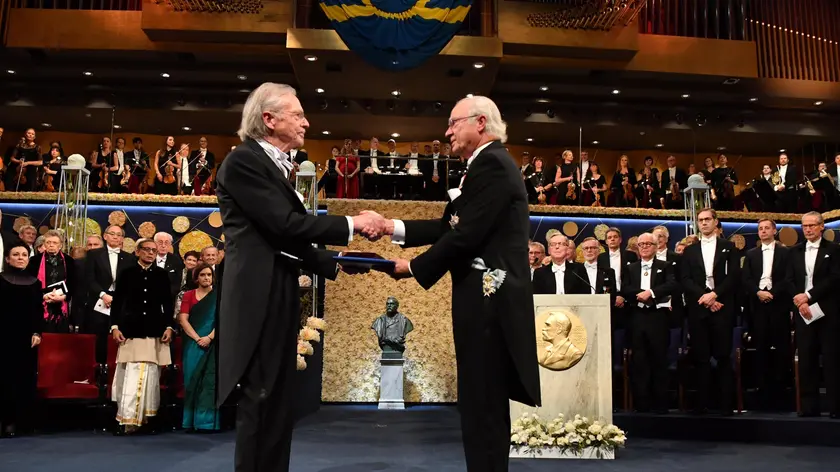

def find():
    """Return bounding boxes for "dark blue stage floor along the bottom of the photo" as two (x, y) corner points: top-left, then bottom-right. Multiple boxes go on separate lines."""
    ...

(0, 406), (840, 472)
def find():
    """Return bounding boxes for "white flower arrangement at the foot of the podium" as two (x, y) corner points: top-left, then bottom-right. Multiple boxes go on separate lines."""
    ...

(510, 413), (627, 457)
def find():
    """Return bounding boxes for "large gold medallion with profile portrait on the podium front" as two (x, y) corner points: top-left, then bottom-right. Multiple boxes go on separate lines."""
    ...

(535, 309), (587, 370)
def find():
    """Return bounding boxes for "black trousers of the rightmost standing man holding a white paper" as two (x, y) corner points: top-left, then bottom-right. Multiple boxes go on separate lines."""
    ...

(795, 313), (840, 414)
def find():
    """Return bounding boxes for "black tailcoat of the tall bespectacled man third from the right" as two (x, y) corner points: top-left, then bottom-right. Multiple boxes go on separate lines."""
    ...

(677, 238), (741, 313)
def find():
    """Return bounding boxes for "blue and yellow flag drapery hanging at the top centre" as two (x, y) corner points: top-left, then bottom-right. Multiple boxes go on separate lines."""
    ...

(319, 0), (472, 70)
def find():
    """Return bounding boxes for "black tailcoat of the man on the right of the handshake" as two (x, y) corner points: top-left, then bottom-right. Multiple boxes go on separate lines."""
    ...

(398, 141), (540, 405)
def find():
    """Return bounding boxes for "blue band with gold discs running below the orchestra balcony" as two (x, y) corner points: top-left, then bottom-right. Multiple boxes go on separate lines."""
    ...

(0, 203), (820, 252)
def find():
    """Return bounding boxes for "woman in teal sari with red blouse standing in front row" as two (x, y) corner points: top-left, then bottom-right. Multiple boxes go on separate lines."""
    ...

(178, 263), (220, 431)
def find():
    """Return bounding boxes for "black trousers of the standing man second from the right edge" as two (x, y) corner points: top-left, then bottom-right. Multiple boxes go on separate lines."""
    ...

(750, 300), (792, 409)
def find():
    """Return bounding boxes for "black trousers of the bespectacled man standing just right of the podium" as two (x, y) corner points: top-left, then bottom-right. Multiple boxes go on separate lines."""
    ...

(630, 308), (670, 411)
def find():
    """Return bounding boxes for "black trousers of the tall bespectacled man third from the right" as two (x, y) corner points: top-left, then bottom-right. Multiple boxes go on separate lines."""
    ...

(688, 308), (735, 412)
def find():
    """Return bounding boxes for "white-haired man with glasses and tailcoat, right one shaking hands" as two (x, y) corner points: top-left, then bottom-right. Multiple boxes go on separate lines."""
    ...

(364, 96), (540, 472)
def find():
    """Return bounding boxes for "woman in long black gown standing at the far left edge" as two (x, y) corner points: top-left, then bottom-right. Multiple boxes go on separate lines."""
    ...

(0, 241), (44, 437)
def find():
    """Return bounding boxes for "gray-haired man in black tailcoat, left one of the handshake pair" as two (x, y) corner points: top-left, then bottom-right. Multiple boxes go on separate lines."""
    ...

(216, 83), (384, 472)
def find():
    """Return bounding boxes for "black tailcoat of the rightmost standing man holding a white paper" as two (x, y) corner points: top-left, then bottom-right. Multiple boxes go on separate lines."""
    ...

(787, 238), (840, 316)
